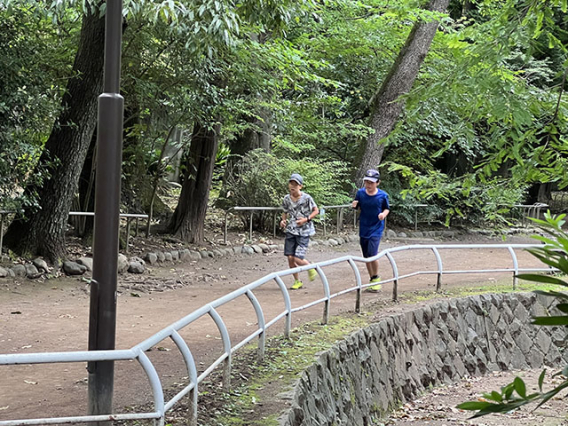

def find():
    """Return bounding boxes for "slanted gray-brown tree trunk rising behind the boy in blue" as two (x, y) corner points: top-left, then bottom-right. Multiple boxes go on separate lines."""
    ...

(355, 0), (449, 187)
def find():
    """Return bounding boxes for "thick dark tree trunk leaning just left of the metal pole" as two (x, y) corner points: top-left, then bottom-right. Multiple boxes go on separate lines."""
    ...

(4, 8), (105, 262)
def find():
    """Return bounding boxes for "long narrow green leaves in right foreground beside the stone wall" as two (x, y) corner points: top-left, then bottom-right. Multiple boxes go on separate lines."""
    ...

(458, 212), (568, 418)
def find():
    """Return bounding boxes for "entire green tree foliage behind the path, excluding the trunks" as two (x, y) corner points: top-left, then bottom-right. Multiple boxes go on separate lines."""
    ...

(0, 0), (568, 245)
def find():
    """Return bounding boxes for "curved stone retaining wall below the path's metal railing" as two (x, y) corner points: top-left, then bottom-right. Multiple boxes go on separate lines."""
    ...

(280, 293), (568, 426)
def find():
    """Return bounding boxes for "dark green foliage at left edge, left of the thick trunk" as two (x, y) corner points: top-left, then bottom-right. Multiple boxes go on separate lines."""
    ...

(0, 8), (68, 210)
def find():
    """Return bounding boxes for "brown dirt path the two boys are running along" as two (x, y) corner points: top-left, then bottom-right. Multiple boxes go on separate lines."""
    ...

(0, 237), (552, 420)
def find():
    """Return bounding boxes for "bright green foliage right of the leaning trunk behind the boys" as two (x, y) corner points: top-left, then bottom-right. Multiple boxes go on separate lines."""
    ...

(385, 1), (568, 223)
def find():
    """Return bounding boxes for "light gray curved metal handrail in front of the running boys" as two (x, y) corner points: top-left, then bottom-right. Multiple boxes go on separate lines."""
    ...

(0, 244), (552, 426)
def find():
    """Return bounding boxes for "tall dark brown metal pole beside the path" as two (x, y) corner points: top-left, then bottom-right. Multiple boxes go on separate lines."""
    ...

(87, 0), (124, 425)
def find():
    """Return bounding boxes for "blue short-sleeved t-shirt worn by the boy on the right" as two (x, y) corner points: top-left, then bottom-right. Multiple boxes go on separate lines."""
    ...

(355, 188), (390, 238)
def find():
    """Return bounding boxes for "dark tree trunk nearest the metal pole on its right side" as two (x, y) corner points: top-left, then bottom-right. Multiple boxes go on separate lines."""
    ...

(168, 123), (220, 243)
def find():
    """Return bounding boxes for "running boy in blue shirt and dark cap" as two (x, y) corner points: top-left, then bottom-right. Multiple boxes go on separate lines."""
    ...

(351, 170), (390, 292)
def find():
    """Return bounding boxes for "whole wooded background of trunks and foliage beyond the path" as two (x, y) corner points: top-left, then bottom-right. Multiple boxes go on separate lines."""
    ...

(0, 0), (568, 262)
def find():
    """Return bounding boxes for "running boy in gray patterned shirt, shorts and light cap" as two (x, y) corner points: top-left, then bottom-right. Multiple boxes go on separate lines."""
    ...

(280, 173), (319, 290)
